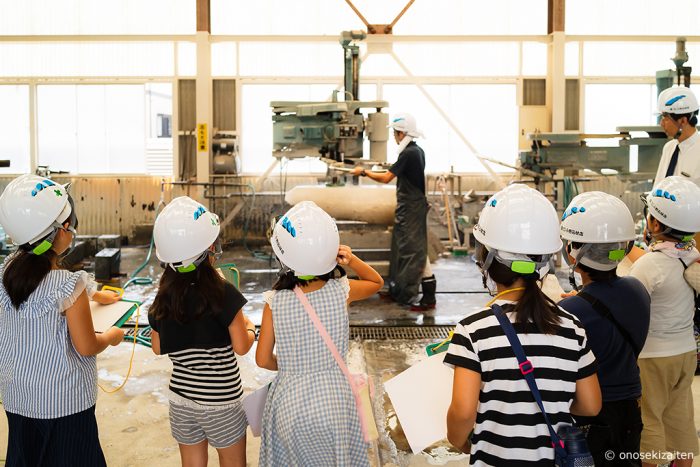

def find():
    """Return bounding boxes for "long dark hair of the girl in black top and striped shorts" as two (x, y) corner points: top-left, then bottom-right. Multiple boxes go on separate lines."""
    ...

(149, 260), (226, 324)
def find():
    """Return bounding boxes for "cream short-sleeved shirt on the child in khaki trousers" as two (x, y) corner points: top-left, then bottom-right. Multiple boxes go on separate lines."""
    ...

(630, 252), (696, 358)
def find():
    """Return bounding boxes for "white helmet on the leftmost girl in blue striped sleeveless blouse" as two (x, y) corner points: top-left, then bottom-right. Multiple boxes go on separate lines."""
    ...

(0, 174), (78, 255)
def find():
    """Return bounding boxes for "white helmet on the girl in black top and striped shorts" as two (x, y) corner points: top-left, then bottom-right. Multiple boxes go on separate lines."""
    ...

(153, 196), (221, 272)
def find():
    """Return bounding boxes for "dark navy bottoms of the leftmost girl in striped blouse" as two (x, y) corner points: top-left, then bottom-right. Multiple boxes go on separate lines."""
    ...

(5, 405), (107, 467)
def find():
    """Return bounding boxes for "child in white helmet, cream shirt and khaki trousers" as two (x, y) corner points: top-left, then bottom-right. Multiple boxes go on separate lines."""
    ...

(630, 177), (700, 467)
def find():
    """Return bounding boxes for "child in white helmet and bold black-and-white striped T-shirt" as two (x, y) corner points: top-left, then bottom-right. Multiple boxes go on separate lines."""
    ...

(444, 186), (601, 465)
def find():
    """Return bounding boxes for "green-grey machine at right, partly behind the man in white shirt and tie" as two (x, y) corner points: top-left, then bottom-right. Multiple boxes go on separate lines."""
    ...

(519, 37), (691, 183)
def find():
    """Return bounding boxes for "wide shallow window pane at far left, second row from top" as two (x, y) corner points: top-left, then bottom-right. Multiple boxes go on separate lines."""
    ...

(0, 43), (175, 77)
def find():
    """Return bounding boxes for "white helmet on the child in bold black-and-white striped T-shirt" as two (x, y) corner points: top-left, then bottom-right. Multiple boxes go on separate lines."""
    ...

(474, 185), (562, 278)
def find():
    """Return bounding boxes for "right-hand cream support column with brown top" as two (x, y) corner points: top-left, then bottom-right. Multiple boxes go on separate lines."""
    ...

(547, 0), (566, 132)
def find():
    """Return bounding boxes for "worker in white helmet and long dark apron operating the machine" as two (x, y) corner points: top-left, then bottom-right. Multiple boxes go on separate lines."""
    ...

(351, 113), (436, 311)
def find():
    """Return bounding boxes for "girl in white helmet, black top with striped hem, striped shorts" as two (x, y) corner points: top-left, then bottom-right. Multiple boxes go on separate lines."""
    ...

(148, 196), (255, 466)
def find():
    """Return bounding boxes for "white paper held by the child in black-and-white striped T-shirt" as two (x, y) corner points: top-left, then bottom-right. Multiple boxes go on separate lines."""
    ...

(384, 353), (454, 454)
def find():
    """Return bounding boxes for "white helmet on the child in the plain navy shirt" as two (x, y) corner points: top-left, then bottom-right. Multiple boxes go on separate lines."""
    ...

(561, 191), (636, 280)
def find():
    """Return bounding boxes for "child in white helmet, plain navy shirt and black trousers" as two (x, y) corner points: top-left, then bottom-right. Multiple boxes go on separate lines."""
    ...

(559, 191), (650, 466)
